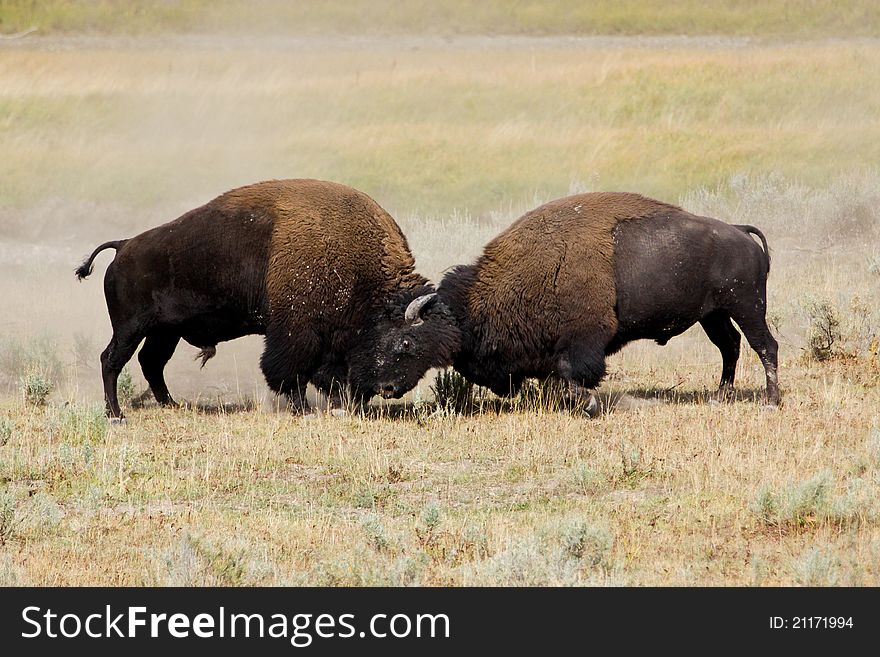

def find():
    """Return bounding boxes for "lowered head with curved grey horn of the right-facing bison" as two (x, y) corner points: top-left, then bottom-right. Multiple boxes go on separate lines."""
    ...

(349, 286), (461, 399)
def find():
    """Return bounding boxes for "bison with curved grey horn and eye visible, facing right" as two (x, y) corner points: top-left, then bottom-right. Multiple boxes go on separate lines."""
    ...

(76, 180), (459, 418)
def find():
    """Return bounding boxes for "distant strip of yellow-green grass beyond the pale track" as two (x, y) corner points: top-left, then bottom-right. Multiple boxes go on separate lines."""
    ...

(0, 0), (880, 37)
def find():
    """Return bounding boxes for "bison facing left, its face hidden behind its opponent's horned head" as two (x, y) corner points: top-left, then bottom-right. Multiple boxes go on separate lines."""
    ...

(396, 193), (779, 410)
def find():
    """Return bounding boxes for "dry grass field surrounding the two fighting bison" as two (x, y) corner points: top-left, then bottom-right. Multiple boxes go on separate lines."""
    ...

(0, 2), (880, 586)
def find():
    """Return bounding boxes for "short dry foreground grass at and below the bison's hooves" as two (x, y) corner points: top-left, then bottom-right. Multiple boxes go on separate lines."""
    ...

(0, 358), (880, 585)
